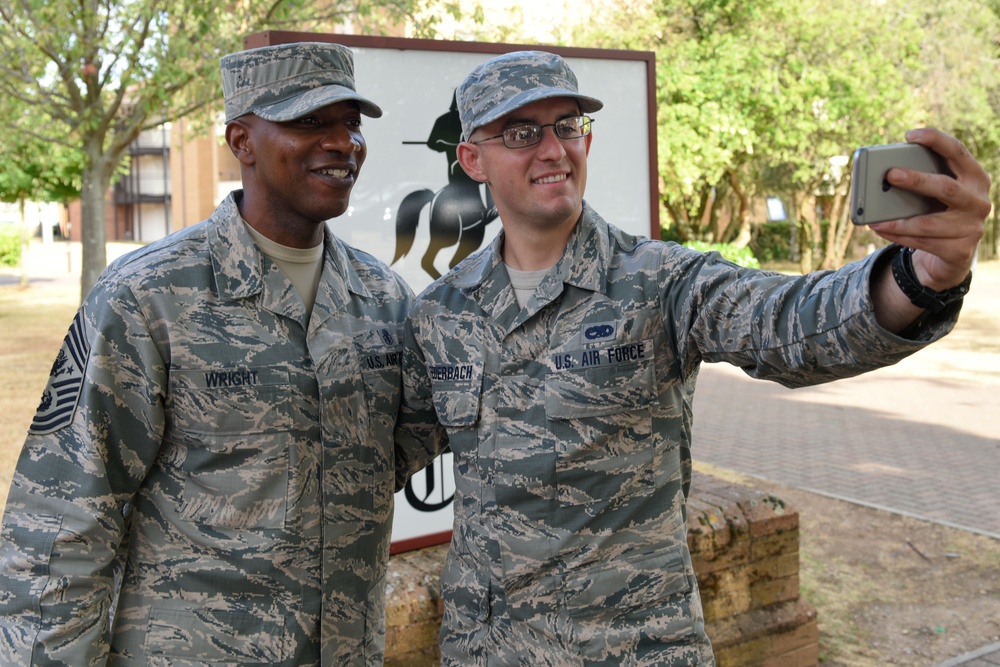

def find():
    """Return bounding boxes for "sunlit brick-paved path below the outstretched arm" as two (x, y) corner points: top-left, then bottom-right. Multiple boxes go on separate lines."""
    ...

(693, 262), (1000, 667)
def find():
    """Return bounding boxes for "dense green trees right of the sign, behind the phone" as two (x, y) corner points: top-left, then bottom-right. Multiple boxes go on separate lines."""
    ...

(577, 0), (1000, 270)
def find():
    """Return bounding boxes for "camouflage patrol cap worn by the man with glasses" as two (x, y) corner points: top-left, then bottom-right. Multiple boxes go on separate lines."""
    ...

(455, 51), (604, 140)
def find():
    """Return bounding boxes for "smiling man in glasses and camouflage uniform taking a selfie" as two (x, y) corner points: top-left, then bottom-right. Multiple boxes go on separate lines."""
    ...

(397, 52), (989, 667)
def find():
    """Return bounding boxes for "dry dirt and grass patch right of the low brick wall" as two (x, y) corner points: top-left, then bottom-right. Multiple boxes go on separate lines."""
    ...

(696, 463), (1000, 667)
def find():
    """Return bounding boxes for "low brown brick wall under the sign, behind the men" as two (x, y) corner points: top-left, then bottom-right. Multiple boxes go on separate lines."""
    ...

(385, 473), (819, 667)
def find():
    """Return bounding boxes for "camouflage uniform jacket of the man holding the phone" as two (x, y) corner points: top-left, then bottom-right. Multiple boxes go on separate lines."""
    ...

(397, 206), (955, 667)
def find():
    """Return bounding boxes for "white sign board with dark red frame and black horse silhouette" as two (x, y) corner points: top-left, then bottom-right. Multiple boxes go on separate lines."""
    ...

(245, 32), (659, 552)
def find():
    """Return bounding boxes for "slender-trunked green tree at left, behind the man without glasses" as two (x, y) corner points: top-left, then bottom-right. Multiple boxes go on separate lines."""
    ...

(0, 0), (440, 296)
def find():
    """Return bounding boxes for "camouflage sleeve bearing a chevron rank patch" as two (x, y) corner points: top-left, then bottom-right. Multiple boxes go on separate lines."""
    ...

(0, 273), (166, 667)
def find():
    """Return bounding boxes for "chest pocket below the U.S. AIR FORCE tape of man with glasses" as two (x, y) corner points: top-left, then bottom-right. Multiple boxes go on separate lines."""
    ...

(545, 342), (659, 506)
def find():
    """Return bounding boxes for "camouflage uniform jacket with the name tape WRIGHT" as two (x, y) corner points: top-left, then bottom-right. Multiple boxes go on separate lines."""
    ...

(0, 192), (410, 667)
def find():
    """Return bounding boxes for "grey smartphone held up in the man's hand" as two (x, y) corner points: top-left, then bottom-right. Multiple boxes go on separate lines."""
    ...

(851, 144), (951, 225)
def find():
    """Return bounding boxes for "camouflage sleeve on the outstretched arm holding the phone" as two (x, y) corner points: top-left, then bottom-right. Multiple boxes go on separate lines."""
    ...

(659, 246), (961, 387)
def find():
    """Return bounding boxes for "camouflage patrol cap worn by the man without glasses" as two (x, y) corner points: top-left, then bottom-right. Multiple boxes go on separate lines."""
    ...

(221, 42), (382, 123)
